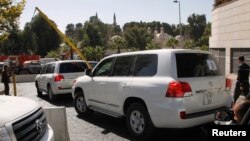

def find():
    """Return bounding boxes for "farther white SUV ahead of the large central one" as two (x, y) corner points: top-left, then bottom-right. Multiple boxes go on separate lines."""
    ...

(35, 60), (88, 101)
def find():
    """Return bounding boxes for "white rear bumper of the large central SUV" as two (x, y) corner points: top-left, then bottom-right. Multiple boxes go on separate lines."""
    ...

(148, 103), (229, 128)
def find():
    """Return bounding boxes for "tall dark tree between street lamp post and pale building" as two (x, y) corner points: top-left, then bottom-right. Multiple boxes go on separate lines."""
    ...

(188, 14), (206, 42)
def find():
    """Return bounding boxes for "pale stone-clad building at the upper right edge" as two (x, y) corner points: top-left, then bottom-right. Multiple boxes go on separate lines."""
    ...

(209, 0), (250, 74)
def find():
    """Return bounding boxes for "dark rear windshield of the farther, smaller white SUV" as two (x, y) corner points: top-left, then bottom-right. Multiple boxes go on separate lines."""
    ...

(59, 62), (87, 73)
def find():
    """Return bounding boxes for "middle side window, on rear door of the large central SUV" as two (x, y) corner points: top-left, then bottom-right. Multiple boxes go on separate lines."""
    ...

(113, 56), (132, 76)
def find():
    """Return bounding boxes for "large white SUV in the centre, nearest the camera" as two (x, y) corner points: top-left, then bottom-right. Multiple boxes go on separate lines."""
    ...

(72, 49), (232, 139)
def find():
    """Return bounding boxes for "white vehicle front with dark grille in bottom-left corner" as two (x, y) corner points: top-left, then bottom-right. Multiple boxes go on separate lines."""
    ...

(0, 96), (54, 141)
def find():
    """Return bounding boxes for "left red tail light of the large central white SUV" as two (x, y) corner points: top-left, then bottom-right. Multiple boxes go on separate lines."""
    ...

(166, 81), (192, 97)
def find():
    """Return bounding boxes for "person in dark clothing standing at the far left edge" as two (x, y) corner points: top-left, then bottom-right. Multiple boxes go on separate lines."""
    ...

(2, 65), (11, 95)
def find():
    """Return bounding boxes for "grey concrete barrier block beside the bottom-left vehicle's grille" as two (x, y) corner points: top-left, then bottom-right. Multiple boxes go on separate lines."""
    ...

(43, 107), (70, 141)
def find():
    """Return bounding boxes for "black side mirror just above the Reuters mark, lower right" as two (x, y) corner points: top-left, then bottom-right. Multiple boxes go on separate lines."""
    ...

(214, 110), (234, 121)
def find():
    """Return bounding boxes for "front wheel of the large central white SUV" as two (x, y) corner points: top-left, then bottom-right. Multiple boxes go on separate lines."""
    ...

(74, 91), (93, 117)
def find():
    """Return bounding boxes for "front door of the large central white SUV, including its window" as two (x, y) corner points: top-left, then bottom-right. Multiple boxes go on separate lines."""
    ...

(85, 58), (114, 109)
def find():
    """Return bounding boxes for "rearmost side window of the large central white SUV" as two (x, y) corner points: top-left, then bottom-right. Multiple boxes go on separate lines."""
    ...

(134, 54), (158, 76)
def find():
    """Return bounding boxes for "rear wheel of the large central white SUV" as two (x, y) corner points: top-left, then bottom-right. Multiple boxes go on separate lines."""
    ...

(126, 103), (155, 141)
